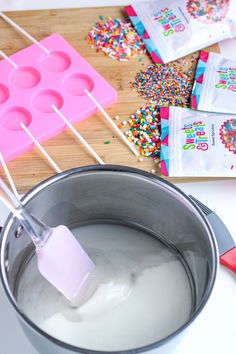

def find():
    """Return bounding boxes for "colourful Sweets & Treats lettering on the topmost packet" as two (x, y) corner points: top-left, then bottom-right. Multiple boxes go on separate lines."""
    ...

(153, 7), (185, 37)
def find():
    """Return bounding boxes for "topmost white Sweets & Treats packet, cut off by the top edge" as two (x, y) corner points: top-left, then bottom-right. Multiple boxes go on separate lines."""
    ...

(126, 0), (236, 64)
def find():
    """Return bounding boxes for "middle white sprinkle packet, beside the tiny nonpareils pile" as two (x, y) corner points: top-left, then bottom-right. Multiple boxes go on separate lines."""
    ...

(191, 51), (236, 114)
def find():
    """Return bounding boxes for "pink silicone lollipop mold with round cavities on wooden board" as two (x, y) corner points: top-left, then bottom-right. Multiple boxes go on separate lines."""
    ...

(0, 34), (117, 161)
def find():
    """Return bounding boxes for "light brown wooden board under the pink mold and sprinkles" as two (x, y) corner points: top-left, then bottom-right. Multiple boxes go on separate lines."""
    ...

(0, 7), (219, 193)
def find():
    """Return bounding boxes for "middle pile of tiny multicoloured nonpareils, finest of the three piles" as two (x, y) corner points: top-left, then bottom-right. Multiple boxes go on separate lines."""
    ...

(131, 55), (197, 107)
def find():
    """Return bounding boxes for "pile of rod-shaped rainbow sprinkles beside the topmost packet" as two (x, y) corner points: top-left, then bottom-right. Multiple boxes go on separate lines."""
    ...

(87, 16), (145, 61)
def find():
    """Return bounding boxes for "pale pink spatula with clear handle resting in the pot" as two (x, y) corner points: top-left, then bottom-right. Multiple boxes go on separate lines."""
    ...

(0, 178), (96, 306)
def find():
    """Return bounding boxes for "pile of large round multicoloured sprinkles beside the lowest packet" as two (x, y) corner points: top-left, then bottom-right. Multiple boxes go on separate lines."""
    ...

(126, 104), (161, 161)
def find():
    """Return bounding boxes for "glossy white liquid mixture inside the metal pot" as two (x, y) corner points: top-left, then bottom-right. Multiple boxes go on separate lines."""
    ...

(18, 224), (192, 351)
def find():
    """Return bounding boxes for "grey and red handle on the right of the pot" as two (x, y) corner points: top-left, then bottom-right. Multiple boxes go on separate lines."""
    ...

(189, 195), (236, 273)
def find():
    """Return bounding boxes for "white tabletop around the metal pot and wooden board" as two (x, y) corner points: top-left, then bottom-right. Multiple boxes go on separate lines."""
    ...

(0, 0), (236, 354)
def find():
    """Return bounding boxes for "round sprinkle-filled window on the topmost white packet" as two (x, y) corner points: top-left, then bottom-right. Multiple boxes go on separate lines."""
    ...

(186, 0), (230, 23)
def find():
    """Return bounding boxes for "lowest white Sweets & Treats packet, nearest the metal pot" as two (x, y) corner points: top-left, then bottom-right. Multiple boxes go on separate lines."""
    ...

(160, 107), (236, 177)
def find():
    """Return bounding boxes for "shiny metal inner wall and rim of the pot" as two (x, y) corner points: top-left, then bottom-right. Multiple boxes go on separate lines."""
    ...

(1, 166), (217, 352)
